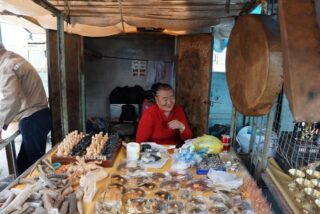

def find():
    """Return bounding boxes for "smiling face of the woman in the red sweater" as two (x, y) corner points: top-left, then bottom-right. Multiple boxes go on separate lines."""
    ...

(156, 89), (175, 112)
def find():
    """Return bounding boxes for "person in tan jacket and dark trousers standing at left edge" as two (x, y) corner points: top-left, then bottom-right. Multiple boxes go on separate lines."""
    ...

(0, 43), (51, 174)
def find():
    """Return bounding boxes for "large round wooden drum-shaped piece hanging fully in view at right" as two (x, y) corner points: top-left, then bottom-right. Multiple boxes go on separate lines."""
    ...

(226, 15), (283, 116)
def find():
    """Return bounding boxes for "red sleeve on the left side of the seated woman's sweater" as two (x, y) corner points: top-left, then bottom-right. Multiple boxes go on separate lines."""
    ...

(136, 110), (152, 143)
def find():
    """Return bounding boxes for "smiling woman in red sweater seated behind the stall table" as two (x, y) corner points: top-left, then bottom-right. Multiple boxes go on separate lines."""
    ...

(136, 84), (192, 145)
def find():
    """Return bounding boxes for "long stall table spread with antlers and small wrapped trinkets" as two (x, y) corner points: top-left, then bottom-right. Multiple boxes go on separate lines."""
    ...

(0, 132), (271, 213)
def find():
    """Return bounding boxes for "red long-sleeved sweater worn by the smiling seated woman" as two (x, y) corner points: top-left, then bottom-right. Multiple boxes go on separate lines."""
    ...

(136, 104), (192, 145)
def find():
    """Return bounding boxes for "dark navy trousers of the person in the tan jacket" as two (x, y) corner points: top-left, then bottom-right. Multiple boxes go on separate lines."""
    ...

(17, 108), (51, 174)
